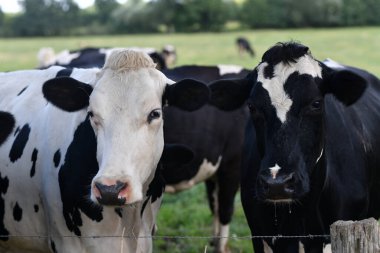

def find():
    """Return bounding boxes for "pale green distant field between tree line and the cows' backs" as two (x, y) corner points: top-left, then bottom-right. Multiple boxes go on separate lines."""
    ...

(0, 27), (380, 76)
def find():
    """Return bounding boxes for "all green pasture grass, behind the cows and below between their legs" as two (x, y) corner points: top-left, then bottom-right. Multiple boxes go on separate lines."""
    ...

(0, 27), (380, 253)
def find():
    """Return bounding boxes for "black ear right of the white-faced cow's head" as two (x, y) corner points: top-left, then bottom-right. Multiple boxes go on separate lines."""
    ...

(163, 79), (210, 111)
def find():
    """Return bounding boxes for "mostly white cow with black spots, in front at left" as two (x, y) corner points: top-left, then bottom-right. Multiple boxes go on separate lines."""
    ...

(0, 49), (209, 253)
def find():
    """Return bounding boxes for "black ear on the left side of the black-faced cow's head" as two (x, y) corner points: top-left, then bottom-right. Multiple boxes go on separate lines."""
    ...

(209, 78), (253, 111)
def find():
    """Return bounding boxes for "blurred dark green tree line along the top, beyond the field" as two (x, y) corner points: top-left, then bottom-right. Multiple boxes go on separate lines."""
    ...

(0, 0), (380, 37)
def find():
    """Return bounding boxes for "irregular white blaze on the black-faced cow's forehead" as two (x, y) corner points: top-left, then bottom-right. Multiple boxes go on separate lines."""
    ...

(257, 55), (322, 123)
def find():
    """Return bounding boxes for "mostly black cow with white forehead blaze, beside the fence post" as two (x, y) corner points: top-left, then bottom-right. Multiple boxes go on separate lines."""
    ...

(210, 42), (380, 253)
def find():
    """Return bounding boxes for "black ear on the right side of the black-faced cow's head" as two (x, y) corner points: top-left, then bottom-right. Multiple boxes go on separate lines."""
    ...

(322, 70), (367, 106)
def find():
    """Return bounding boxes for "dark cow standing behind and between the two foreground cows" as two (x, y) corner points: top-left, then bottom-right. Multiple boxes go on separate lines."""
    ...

(163, 65), (249, 252)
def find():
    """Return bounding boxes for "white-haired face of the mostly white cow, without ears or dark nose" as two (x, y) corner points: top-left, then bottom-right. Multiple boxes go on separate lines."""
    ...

(89, 68), (167, 204)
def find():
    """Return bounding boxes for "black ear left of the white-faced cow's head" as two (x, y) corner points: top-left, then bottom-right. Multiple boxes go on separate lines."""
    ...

(42, 77), (93, 112)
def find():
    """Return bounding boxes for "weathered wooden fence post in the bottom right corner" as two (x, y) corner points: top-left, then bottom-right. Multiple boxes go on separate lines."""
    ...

(330, 218), (380, 253)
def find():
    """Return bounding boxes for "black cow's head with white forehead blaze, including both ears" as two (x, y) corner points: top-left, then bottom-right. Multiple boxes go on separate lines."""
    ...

(210, 43), (366, 202)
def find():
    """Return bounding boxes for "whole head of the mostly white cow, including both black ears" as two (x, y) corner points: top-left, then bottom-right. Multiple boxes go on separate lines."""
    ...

(43, 49), (209, 205)
